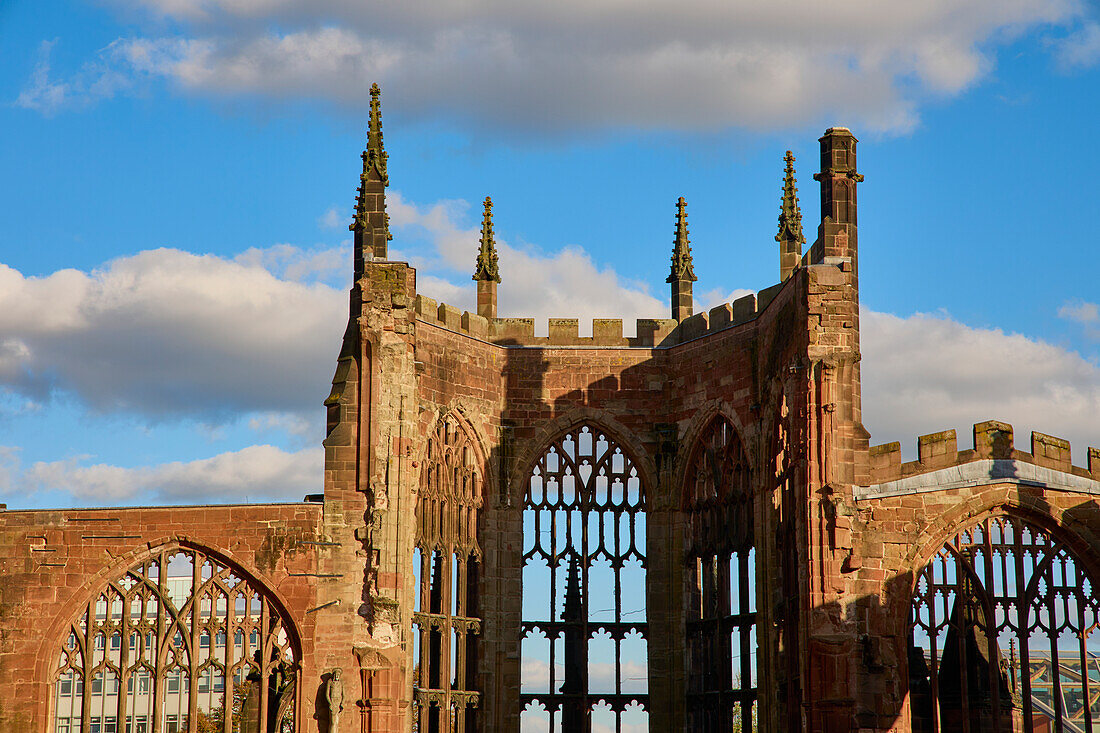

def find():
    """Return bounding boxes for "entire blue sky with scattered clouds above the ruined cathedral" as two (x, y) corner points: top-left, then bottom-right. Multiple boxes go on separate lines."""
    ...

(0, 0), (1100, 508)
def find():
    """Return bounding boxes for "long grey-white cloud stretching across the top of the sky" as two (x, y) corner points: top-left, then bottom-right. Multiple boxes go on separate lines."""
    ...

(21, 0), (1084, 132)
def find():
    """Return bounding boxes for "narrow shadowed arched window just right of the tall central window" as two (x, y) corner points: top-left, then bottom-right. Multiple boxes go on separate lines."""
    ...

(682, 415), (757, 733)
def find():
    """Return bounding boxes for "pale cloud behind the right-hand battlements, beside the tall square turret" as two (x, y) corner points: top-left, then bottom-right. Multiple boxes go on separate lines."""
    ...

(860, 310), (1100, 464)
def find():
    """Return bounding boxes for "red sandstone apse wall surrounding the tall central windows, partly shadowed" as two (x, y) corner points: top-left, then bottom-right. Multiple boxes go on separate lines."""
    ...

(404, 264), (809, 731)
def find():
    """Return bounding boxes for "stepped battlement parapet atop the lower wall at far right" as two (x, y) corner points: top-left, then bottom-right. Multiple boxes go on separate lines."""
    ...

(869, 420), (1100, 483)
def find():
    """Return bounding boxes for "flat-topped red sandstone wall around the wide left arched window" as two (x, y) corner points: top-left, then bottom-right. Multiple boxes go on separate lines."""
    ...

(0, 504), (322, 733)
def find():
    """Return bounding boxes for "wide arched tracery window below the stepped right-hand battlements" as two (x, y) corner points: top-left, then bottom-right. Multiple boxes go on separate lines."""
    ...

(909, 516), (1100, 733)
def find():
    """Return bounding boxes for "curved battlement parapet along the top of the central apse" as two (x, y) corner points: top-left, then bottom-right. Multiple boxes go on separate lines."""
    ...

(415, 283), (783, 349)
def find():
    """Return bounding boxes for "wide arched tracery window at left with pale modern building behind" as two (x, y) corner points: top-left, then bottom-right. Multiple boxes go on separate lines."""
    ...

(54, 546), (300, 733)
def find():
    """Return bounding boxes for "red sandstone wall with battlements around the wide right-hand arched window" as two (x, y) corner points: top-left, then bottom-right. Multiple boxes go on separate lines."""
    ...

(849, 420), (1100, 732)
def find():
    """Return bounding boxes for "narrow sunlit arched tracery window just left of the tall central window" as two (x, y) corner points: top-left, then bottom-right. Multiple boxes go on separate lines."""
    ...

(413, 415), (483, 733)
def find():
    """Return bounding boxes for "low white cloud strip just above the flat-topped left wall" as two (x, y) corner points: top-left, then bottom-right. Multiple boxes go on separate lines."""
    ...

(0, 445), (325, 505)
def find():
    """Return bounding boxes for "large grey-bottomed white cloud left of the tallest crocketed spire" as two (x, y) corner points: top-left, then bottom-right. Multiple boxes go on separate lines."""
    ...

(0, 249), (348, 422)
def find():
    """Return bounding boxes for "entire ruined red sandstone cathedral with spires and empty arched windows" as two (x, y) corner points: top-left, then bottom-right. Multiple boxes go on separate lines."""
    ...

(0, 87), (1100, 733)
